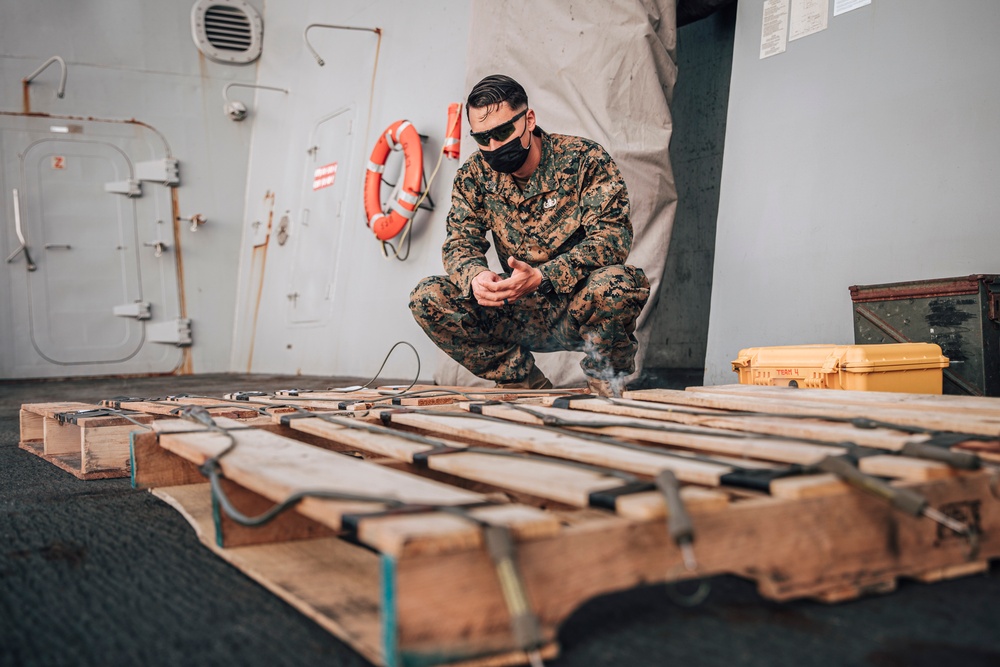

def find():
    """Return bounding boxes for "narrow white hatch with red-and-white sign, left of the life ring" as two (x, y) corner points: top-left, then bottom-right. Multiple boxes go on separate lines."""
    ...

(288, 105), (359, 324)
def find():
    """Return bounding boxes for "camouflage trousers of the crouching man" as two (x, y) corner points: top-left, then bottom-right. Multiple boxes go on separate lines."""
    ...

(410, 265), (649, 383)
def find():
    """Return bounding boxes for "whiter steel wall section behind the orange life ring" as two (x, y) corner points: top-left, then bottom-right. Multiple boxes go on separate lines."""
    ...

(231, 0), (469, 379)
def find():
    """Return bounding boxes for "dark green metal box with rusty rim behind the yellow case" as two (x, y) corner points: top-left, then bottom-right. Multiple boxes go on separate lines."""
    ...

(850, 274), (1000, 396)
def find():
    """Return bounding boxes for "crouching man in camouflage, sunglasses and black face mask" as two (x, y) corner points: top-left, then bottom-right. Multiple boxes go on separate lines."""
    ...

(410, 75), (649, 396)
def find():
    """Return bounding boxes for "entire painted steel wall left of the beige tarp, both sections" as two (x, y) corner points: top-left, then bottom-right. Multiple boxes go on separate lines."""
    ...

(0, 0), (469, 377)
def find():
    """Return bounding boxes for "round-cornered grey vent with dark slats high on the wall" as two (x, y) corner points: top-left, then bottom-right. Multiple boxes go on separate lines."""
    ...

(191, 0), (264, 65)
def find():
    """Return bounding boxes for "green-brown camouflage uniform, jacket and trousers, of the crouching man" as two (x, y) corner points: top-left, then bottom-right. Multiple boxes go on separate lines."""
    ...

(410, 130), (649, 383)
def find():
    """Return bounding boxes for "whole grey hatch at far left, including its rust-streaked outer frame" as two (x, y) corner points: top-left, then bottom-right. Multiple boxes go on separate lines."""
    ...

(0, 116), (183, 377)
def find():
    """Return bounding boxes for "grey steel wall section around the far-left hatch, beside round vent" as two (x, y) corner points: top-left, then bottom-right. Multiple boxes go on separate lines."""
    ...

(0, 0), (262, 373)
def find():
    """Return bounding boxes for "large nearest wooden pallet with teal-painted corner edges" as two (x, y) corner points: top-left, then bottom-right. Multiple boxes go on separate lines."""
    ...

(119, 388), (1000, 665)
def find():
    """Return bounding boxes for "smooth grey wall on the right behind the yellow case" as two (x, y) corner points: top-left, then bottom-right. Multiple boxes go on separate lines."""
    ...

(705, 0), (1000, 384)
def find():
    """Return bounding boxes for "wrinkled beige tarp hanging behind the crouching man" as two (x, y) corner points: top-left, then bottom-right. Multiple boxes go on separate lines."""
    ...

(434, 0), (677, 386)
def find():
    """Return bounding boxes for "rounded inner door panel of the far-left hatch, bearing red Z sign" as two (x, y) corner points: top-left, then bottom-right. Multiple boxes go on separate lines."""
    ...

(18, 139), (143, 364)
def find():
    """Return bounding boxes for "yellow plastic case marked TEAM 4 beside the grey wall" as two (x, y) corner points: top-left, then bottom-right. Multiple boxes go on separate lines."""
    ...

(733, 343), (949, 394)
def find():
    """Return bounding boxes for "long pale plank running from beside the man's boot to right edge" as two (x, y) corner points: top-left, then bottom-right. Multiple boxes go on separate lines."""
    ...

(624, 389), (1000, 437)
